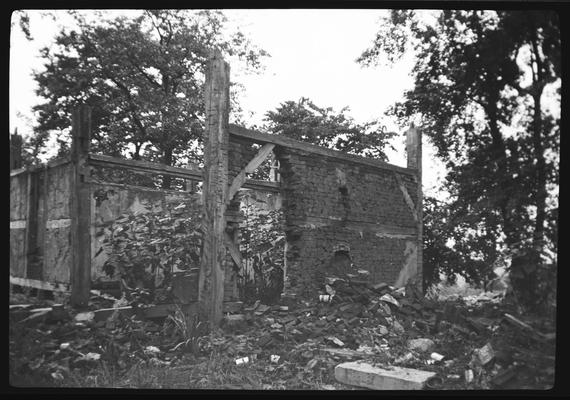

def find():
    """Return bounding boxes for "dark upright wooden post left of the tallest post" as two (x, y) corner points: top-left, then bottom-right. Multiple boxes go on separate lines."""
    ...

(70, 106), (91, 307)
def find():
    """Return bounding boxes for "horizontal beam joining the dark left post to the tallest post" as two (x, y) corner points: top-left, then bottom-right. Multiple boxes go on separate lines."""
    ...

(89, 154), (202, 180)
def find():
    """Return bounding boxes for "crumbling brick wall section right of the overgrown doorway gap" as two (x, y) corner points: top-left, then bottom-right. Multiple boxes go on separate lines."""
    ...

(276, 147), (421, 296)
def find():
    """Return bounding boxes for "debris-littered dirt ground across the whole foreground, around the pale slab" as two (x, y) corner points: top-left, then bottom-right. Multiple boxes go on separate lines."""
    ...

(6, 280), (556, 390)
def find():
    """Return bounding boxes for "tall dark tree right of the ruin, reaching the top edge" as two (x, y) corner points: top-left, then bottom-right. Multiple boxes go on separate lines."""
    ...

(358, 10), (560, 308)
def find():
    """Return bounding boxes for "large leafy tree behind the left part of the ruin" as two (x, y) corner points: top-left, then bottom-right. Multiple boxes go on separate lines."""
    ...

(34, 10), (267, 186)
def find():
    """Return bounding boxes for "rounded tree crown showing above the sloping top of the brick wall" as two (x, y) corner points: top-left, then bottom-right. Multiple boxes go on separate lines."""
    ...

(265, 98), (395, 161)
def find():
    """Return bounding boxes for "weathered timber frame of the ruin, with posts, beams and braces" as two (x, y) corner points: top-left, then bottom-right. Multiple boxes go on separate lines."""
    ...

(10, 51), (423, 328)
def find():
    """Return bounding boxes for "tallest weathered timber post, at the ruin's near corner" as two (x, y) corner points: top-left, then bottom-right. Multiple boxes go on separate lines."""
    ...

(198, 50), (230, 329)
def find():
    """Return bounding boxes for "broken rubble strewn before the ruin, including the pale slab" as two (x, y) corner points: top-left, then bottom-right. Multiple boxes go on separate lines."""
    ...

(10, 273), (555, 389)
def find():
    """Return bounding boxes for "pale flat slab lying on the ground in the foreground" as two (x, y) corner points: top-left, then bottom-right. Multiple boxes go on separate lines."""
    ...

(334, 361), (436, 390)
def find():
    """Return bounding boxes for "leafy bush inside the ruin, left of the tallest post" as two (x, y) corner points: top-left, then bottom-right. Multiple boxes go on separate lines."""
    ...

(103, 198), (202, 303)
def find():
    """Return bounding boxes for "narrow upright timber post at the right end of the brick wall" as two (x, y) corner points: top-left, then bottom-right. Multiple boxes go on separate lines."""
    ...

(406, 124), (424, 291)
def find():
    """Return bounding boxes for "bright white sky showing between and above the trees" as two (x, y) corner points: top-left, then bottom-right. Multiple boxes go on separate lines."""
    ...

(10, 10), (443, 193)
